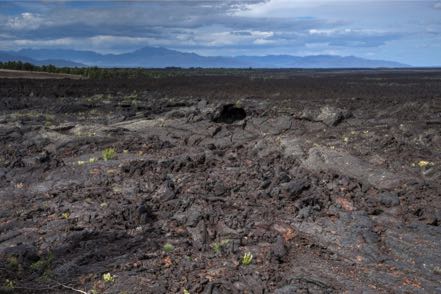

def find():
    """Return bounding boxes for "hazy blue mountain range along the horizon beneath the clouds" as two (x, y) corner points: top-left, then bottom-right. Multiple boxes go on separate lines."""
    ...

(0, 47), (409, 68)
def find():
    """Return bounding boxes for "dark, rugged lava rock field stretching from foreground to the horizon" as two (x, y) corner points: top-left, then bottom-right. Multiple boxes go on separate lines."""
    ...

(0, 71), (441, 294)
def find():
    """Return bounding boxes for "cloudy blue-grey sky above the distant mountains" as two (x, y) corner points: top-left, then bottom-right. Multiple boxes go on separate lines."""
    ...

(0, 0), (441, 66)
